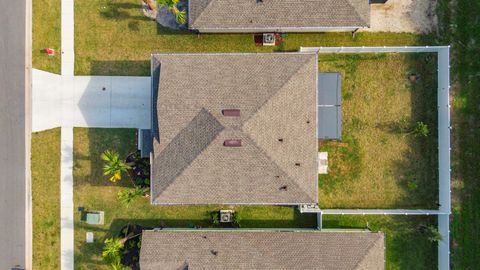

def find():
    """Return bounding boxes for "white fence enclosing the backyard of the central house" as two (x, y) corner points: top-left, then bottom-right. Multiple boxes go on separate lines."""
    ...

(300, 46), (451, 270)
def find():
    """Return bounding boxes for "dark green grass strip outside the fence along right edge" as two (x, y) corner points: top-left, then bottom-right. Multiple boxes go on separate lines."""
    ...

(438, 0), (480, 269)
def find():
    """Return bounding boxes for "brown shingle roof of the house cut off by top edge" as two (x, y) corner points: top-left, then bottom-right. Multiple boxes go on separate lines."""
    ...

(189, 0), (370, 29)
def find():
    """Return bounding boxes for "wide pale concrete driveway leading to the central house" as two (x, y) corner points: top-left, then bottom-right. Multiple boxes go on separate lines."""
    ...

(32, 69), (151, 131)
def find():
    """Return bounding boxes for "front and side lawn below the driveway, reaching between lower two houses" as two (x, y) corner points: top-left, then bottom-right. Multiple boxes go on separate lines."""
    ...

(74, 128), (316, 269)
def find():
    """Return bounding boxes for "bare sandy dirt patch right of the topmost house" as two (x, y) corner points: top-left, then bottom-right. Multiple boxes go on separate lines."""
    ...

(362, 0), (437, 34)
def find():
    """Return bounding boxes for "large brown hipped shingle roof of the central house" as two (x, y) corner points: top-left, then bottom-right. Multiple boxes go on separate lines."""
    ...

(152, 53), (318, 204)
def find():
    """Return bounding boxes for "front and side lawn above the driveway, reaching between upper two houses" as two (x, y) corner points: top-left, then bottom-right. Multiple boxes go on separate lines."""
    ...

(75, 0), (429, 75)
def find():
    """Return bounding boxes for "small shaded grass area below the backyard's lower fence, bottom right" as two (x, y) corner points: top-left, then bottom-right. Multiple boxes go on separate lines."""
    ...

(323, 215), (437, 270)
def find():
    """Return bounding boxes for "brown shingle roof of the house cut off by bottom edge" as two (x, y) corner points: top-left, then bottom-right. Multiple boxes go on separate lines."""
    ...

(140, 230), (385, 270)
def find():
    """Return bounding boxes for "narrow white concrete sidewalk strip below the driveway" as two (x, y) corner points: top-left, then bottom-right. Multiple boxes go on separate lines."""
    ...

(60, 127), (74, 270)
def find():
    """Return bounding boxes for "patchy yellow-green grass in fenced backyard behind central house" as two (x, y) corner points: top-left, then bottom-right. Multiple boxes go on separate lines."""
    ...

(319, 54), (438, 209)
